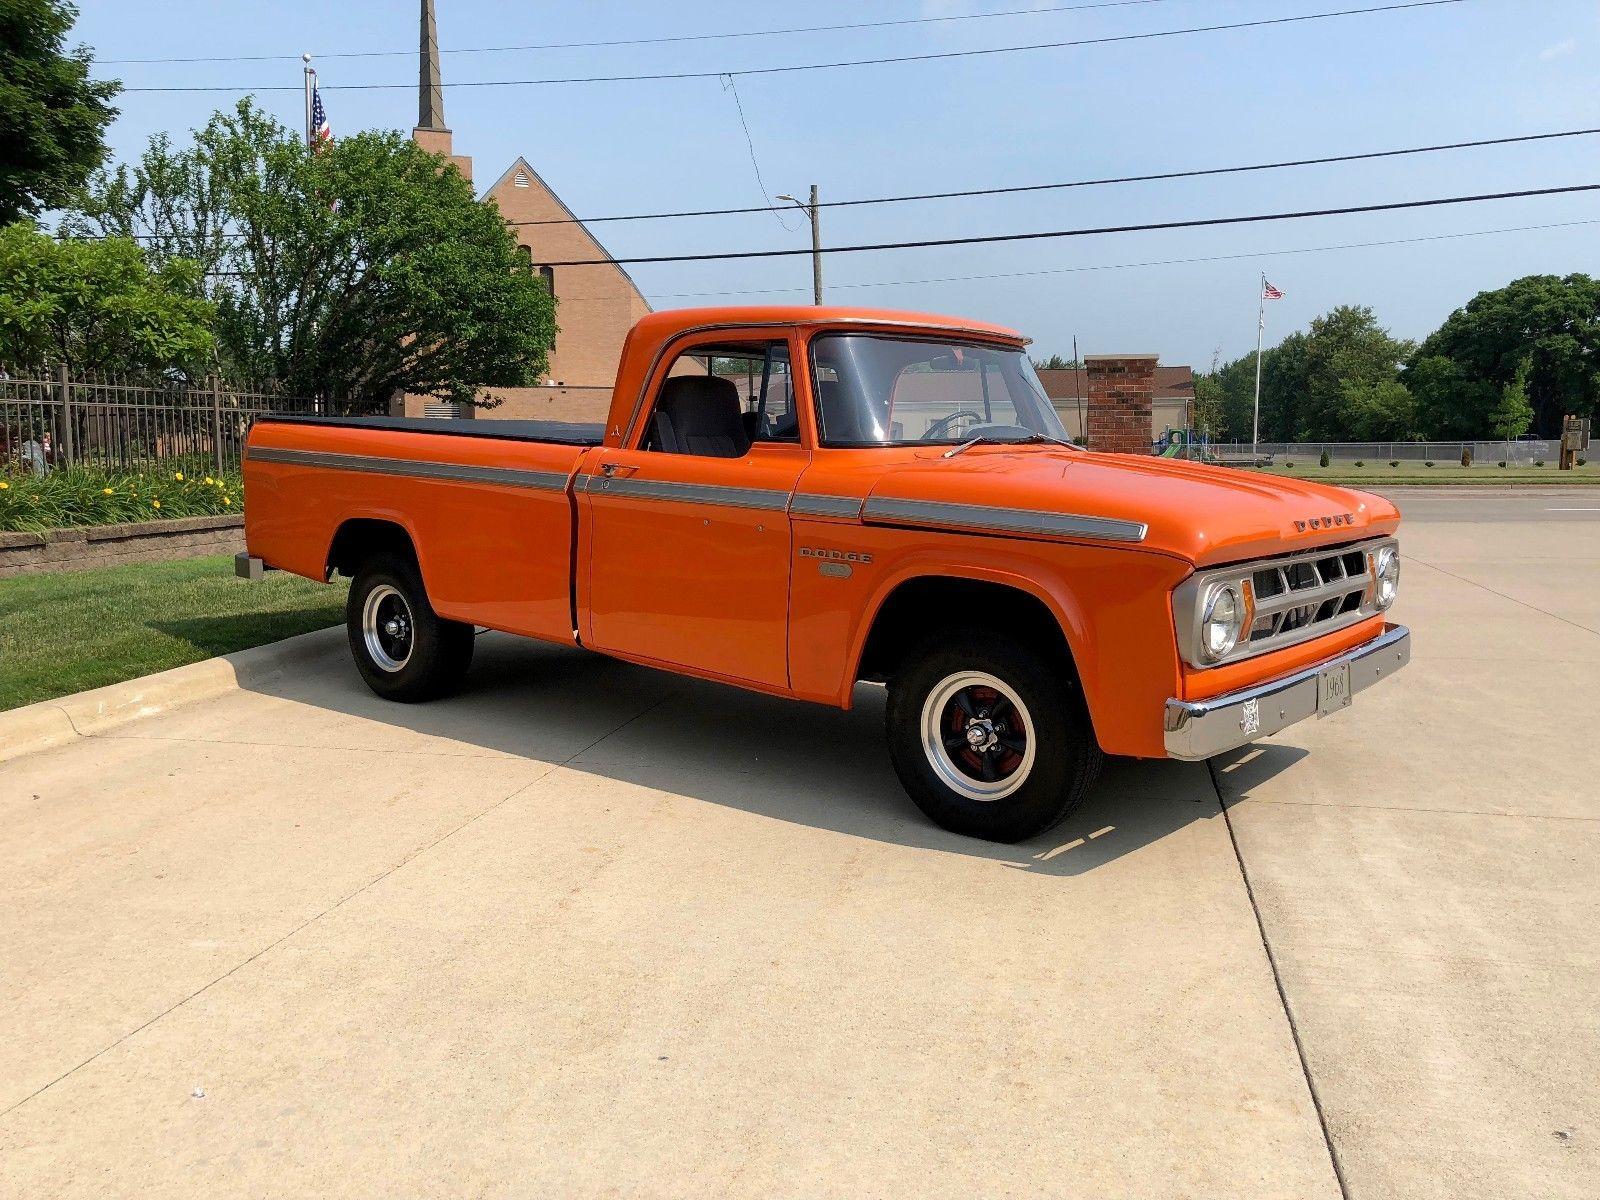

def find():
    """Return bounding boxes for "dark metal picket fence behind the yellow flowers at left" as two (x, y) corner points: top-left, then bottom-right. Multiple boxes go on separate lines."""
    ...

(0, 365), (326, 474)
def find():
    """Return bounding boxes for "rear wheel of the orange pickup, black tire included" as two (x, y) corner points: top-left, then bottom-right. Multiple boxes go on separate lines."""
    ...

(344, 554), (474, 704)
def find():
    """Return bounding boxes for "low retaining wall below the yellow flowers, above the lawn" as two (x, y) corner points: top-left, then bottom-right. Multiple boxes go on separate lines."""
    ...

(0, 515), (245, 579)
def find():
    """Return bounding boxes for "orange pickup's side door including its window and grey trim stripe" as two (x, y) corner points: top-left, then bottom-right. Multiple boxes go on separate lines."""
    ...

(582, 331), (810, 688)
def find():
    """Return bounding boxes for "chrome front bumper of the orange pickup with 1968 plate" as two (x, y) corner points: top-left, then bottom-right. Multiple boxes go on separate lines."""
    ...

(1166, 626), (1411, 762)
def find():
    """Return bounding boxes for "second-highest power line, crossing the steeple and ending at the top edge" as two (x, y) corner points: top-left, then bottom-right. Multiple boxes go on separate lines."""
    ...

(122, 0), (1467, 94)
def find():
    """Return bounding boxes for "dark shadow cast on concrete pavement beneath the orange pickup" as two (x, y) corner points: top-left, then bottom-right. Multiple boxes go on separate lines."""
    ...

(222, 635), (1286, 875)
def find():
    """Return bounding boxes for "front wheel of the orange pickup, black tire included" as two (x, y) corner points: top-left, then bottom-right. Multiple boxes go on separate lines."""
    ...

(888, 627), (1102, 842)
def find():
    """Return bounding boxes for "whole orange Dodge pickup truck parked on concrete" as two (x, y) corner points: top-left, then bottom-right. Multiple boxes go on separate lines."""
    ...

(238, 307), (1410, 842)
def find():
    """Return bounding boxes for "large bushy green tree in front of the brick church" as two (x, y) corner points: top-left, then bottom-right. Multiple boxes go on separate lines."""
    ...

(75, 101), (555, 413)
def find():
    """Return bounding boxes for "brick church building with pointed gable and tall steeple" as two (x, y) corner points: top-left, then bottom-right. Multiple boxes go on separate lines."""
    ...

(395, 0), (650, 421)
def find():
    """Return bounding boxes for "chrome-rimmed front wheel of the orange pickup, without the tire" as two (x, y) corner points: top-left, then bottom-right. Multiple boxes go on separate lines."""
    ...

(922, 670), (1037, 802)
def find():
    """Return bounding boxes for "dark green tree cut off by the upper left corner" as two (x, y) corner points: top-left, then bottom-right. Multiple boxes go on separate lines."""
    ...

(0, 0), (122, 224)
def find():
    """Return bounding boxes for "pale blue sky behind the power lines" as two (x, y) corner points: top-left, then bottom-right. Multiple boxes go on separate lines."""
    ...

(75, 0), (1600, 366)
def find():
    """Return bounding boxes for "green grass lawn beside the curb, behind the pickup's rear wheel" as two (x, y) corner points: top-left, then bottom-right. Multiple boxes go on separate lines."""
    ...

(0, 555), (346, 709)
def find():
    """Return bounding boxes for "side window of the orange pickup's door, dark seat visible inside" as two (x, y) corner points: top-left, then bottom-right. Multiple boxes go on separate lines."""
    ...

(645, 341), (800, 458)
